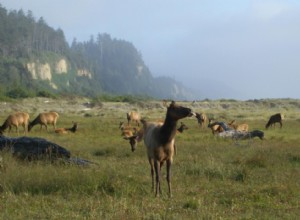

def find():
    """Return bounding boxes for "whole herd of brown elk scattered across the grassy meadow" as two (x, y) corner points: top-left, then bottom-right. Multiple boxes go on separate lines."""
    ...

(0, 101), (284, 196)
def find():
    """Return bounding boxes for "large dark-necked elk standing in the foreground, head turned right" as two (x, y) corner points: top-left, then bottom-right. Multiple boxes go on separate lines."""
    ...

(142, 101), (194, 196)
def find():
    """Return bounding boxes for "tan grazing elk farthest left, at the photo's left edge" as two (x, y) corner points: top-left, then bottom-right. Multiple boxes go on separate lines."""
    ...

(0, 112), (29, 134)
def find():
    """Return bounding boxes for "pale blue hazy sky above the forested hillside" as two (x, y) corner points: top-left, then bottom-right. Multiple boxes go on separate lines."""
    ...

(0, 0), (300, 100)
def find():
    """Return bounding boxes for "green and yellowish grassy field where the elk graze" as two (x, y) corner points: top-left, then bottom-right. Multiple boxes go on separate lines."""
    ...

(0, 99), (300, 220)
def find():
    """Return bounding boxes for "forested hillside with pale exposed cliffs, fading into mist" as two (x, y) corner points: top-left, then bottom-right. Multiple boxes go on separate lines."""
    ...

(0, 5), (194, 100)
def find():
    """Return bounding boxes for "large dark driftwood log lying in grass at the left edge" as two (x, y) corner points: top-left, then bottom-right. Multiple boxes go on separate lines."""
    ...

(0, 136), (71, 160)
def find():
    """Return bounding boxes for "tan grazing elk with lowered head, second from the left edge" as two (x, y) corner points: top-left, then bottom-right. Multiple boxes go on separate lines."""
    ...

(28, 112), (59, 131)
